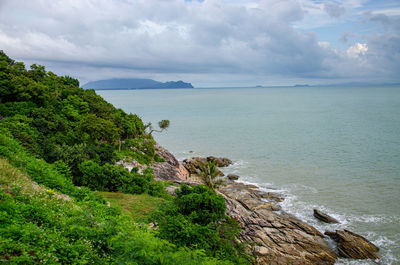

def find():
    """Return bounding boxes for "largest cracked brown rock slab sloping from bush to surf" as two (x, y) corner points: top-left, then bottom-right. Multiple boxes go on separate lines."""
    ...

(220, 183), (337, 265)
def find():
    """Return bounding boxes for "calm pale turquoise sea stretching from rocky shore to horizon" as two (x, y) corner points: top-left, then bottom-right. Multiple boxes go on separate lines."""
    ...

(97, 86), (400, 264)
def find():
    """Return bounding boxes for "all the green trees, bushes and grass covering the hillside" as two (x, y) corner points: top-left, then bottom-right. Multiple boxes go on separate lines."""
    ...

(0, 51), (250, 264)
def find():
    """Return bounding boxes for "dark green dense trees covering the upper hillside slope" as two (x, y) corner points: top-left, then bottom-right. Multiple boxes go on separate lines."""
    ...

(0, 51), (162, 195)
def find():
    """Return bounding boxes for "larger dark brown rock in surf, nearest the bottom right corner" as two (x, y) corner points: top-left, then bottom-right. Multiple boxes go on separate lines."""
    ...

(325, 230), (381, 259)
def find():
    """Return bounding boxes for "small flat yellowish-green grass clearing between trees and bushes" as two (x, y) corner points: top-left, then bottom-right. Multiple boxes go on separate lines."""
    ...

(99, 192), (164, 222)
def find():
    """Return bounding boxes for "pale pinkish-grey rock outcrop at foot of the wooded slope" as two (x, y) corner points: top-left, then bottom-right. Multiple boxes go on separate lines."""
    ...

(151, 145), (190, 181)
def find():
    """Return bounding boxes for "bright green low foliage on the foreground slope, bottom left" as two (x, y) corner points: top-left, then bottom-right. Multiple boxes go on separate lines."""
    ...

(0, 159), (230, 265)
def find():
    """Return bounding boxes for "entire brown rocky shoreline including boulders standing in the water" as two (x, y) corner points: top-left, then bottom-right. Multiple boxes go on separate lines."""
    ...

(120, 146), (380, 264)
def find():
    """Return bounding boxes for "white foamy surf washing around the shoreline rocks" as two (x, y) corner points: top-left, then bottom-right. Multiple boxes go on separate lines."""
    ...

(224, 160), (400, 265)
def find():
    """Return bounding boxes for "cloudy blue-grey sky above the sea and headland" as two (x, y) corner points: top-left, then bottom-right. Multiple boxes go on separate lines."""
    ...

(0, 0), (400, 87)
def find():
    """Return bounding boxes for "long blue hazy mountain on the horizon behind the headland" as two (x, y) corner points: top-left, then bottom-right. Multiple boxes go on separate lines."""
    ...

(82, 78), (193, 90)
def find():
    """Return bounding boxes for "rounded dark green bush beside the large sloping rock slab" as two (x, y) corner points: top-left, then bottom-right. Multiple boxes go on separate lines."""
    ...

(153, 185), (250, 264)
